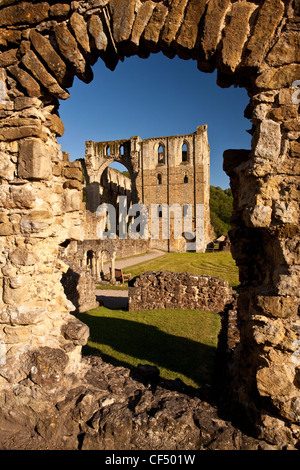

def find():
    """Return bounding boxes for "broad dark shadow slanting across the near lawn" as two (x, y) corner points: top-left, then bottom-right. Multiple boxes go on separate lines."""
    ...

(78, 314), (216, 387)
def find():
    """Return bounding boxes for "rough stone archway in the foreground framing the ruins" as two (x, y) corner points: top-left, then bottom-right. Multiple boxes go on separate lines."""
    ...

(0, 0), (300, 448)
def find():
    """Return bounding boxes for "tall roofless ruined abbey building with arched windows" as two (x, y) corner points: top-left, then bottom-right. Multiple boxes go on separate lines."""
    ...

(84, 125), (212, 252)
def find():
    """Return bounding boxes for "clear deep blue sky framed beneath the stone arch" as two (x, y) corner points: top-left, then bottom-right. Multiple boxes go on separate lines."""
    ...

(58, 53), (251, 189)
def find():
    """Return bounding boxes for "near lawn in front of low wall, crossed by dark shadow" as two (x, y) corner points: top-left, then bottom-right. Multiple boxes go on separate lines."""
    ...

(78, 307), (220, 387)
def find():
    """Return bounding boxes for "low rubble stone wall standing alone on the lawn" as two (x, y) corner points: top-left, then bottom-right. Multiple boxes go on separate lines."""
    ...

(128, 271), (234, 312)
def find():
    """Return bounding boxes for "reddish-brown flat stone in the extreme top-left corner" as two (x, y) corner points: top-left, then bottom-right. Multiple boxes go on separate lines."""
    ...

(0, 2), (49, 26)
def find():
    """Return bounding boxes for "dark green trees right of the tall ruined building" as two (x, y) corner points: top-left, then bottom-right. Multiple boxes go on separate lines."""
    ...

(209, 186), (233, 237)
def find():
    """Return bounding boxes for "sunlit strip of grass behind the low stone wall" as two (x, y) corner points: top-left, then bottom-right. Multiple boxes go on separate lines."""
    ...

(123, 252), (239, 288)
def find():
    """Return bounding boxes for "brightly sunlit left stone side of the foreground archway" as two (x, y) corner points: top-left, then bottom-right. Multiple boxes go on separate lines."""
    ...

(0, 95), (87, 400)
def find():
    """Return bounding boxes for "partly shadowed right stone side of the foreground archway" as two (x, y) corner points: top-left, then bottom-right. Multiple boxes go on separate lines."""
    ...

(224, 82), (300, 443)
